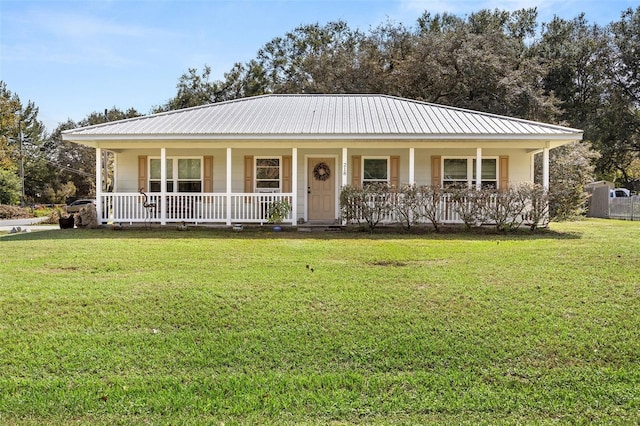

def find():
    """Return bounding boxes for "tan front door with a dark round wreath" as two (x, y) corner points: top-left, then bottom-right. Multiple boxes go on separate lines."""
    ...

(307, 158), (336, 223)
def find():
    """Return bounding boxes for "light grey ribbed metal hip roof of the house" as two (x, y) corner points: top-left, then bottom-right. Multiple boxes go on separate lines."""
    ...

(63, 95), (582, 140)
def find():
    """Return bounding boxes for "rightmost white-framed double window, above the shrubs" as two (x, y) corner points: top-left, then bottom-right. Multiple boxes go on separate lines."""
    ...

(442, 157), (498, 188)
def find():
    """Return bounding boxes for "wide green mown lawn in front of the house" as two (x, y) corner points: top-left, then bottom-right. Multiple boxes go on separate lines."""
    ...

(0, 220), (640, 424)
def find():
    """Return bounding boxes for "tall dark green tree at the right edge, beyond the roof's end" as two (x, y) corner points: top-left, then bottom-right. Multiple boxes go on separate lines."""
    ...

(537, 8), (640, 187)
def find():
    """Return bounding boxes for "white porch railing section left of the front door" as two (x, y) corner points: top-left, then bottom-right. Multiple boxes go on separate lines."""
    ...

(100, 192), (295, 224)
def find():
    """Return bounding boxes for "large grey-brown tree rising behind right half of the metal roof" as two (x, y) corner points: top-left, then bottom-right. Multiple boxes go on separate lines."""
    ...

(398, 9), (556, 121)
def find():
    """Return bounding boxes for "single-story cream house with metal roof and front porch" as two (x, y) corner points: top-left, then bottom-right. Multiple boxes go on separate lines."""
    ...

(62, 95), (582, 225)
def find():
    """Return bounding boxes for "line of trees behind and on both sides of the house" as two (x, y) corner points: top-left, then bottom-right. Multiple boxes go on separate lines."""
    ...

(0, 7), (640, 211)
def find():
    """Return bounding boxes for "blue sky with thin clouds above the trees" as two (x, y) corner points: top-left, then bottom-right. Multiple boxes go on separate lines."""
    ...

(0, 0), (638, 132)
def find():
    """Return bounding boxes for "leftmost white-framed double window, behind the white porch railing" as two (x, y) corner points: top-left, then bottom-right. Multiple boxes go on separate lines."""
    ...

(149, 158), (202, 192)
